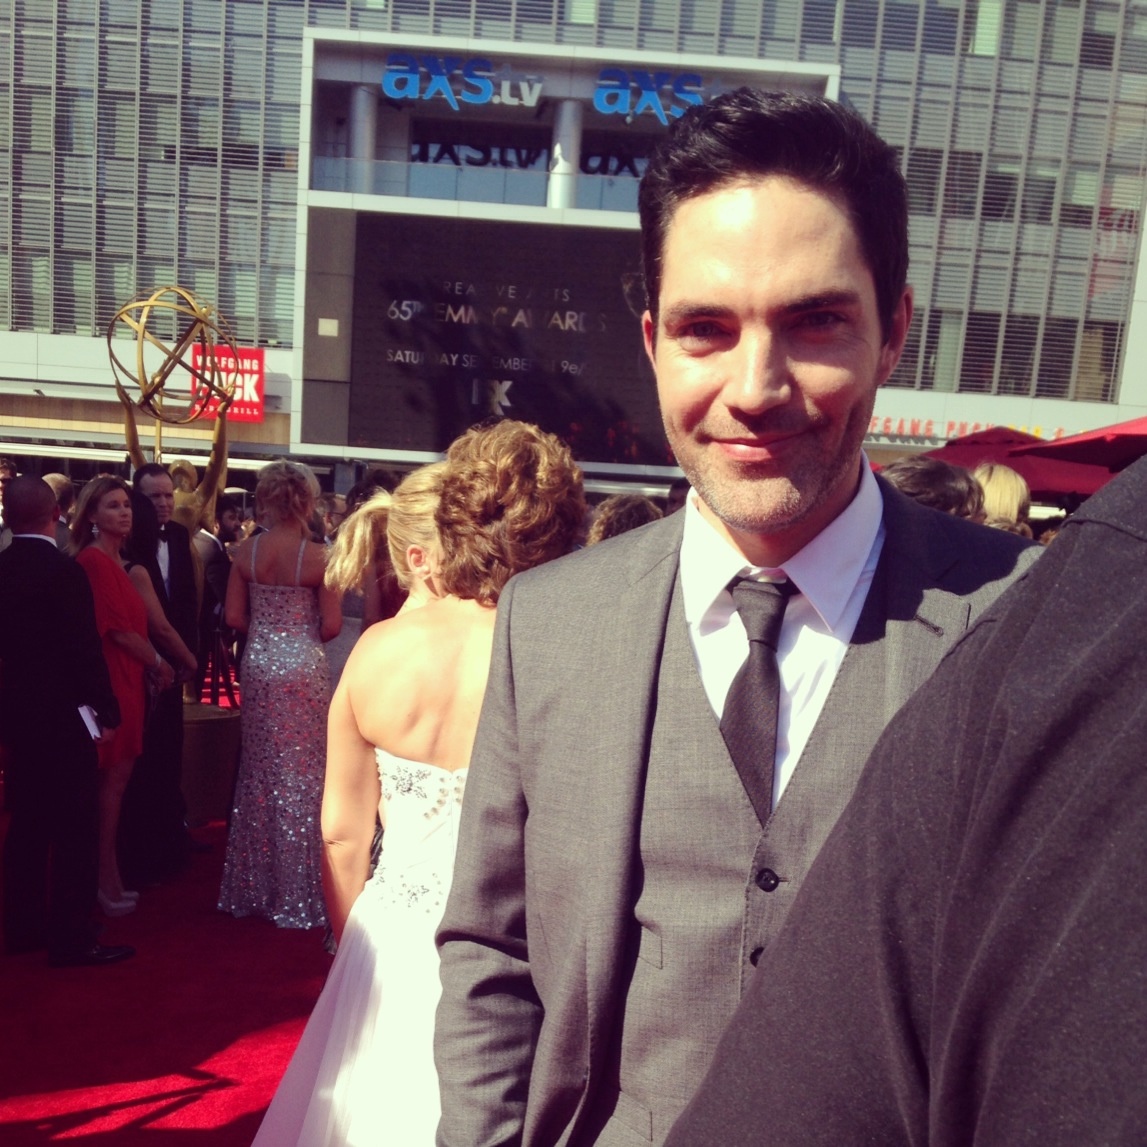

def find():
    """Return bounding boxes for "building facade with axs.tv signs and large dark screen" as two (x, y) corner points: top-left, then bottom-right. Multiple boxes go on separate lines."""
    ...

(0, 0), (1147, 477)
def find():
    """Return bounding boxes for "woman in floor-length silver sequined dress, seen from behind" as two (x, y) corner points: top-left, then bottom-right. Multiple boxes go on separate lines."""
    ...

(219, 462), (342, 928)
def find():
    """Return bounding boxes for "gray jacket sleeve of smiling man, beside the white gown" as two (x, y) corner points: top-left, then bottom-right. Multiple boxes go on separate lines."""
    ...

(435, 582), (541, 1147)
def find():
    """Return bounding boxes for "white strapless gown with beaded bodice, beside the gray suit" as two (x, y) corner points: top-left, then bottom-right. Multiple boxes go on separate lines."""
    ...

(255, 749), (468, 1147)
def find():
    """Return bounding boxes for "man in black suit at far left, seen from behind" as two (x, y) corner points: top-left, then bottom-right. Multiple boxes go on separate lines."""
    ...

(0, 476), (134, 967)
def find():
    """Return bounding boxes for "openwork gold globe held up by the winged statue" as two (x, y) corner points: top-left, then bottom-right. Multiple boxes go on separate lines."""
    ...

(108, 287), (239, 432)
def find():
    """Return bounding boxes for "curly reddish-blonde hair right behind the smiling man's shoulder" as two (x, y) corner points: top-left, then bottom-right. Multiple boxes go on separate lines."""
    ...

(435, 419), (585, 606)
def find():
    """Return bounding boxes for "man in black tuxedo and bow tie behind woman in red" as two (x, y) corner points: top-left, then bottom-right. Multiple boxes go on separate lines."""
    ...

(119, 462), (198, 884)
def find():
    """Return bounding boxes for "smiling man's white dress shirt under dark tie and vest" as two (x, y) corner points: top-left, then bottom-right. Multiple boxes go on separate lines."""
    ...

(680, 459), (884, 807)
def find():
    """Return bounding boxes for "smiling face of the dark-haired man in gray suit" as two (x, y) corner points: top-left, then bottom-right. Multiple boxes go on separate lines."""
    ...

(643, 175), (912, 564)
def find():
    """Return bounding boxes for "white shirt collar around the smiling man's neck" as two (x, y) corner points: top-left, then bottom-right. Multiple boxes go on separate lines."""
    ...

(680, 454), (884, 630)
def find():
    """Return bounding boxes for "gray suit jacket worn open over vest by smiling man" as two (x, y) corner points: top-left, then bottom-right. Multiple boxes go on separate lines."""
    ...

(436, 485), (1038, 1147)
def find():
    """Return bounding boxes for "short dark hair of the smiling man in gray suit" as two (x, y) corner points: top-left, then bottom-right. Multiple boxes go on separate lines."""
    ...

(638, 87), (908, 340)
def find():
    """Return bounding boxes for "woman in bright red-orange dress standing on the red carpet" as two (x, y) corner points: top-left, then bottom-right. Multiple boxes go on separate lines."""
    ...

(71, 477), (174, 915)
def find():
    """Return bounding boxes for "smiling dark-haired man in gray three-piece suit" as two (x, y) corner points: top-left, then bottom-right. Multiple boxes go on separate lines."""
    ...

(436, 89), (1032, 1147)
